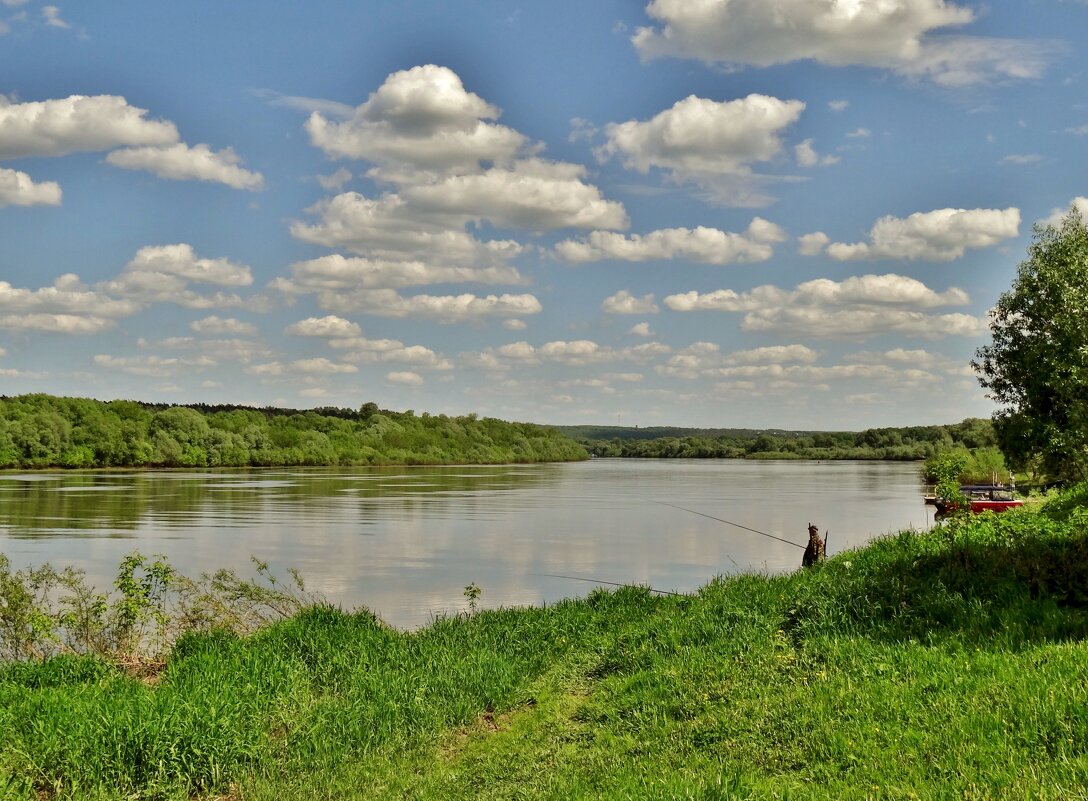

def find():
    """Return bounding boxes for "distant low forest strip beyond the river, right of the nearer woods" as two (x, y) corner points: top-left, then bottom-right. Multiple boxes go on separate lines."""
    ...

(556, 418), (997, 461)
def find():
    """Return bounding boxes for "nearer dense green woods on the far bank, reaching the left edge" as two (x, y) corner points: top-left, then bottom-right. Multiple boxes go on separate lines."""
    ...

(0, 394), (588, 468)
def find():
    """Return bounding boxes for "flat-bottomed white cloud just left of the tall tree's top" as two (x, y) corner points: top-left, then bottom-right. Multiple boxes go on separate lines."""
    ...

(827, 208), (1021, 261)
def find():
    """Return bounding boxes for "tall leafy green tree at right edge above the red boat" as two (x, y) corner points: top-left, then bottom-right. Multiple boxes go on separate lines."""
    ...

(972, 207), (1088, 480)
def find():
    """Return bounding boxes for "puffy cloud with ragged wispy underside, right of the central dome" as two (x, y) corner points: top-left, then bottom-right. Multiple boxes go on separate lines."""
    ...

(598, 94), (805, 206)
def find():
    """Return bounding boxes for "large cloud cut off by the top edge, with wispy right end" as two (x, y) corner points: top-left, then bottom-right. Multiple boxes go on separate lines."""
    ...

(632, 0), (1048, 85)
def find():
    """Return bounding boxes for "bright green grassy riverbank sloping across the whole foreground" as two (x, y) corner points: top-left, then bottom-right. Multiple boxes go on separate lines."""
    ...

(0, 491), (1088, 801)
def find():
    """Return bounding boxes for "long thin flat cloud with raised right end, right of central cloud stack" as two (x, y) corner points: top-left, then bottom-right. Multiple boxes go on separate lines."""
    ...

(555, 217), (786, 264)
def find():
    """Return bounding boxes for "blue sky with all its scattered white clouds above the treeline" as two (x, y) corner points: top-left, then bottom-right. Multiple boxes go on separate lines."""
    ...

(0, 0), (1088, 430)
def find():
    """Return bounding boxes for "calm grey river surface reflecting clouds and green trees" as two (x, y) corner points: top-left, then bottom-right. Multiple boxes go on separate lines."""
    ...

(0, 459), (932, 628)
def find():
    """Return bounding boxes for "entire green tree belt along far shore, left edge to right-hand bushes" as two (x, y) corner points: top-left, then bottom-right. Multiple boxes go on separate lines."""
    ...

(0, 394), (1006, 472)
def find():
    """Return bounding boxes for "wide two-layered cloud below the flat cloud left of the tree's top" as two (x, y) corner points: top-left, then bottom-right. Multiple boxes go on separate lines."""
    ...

(665, 273), (987, 338)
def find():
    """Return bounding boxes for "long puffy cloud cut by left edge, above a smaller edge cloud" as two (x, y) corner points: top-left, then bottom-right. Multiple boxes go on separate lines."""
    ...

(0, 95), (178, 159)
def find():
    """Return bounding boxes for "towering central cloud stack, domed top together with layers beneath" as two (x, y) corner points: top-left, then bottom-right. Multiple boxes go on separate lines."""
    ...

(292, 64), (628, 267)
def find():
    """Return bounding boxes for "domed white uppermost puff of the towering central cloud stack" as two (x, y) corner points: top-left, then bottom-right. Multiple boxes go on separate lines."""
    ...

(306, 64), (528, 172)
